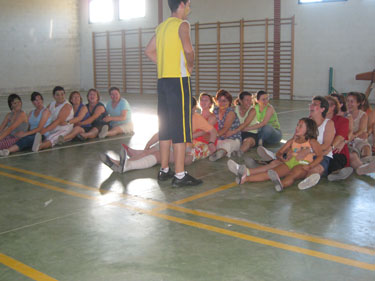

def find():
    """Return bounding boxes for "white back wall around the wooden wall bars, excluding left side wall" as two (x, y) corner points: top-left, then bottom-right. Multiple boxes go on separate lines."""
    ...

(81, 0), (375, 100)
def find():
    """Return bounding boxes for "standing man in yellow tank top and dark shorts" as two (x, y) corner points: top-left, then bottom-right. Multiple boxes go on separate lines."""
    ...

(145, 0), (202, 187)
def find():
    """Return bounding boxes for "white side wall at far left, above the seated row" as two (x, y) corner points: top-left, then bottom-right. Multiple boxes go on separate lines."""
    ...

(0, 0), (80, 95)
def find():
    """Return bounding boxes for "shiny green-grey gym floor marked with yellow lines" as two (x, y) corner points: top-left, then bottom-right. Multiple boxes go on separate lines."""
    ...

(0, 94), (375, 281)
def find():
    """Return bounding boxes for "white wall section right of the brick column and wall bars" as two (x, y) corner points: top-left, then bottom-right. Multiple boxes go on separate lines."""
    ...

(282, 0), (375, 101)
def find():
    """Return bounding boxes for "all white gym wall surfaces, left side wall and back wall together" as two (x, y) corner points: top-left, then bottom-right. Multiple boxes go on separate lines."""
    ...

(0, 0), (375, 101)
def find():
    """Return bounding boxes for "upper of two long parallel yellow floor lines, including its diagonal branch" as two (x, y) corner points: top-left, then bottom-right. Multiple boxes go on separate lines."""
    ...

(0, 164), (375, 256)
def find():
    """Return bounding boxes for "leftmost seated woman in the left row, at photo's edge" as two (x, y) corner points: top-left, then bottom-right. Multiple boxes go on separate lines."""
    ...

(0, 94), (28, 150)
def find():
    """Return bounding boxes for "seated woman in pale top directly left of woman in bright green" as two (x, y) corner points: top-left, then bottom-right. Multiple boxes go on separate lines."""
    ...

(225, 92), (258, 156)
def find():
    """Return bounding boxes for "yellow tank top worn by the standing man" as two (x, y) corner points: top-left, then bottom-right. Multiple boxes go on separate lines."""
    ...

(156, 17), (190, 79)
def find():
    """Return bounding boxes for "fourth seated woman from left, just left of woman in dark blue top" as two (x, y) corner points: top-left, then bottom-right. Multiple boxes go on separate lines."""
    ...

(57, 91), (90, 144)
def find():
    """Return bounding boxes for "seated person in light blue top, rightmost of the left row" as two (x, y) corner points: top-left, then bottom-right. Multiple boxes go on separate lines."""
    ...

(99, 87), (134, 138)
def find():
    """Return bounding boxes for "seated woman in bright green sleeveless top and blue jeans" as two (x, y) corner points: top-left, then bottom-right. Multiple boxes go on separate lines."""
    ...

(248, 91), (282, 144)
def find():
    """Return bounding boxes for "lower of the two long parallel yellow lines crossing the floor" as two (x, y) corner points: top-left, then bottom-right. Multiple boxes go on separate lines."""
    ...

(0, 172), (375, 271)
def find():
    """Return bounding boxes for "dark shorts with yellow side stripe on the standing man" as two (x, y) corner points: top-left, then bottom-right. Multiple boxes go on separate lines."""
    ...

(158, 77), (192, 143)
